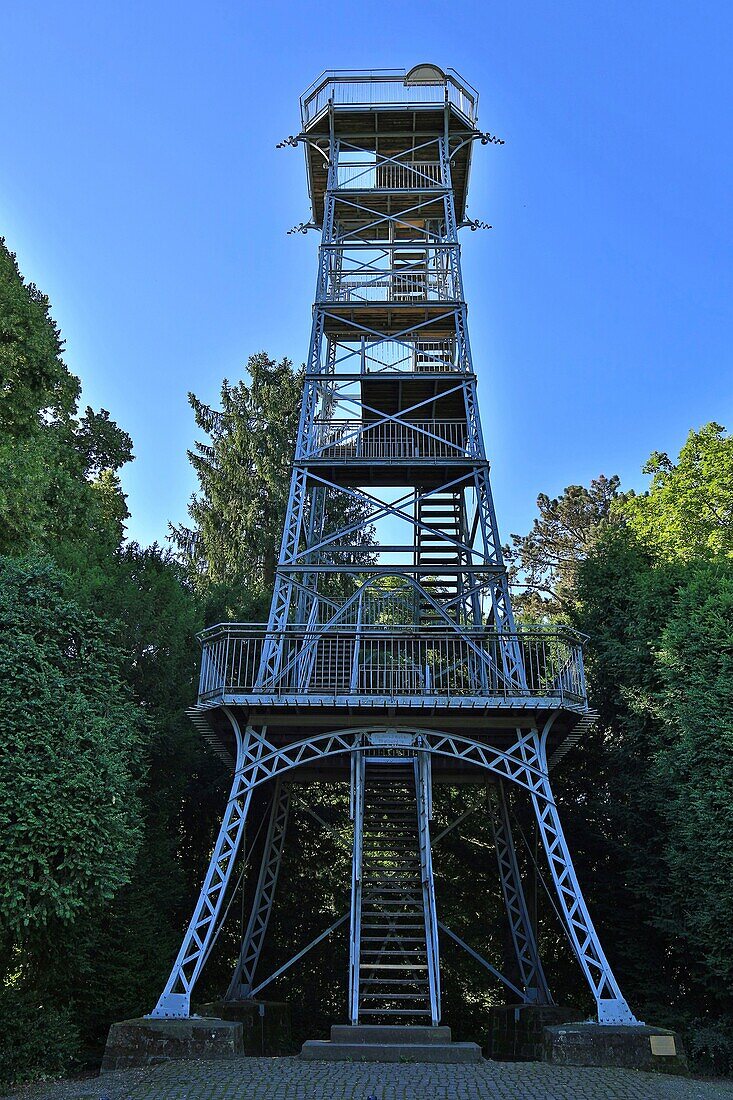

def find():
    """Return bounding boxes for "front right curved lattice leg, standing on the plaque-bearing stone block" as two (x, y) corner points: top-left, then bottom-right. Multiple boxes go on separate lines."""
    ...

(519, 727), (639, 1024)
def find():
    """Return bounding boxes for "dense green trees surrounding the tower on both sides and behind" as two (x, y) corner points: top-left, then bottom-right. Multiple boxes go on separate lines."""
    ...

(0, 236), (733, 1086)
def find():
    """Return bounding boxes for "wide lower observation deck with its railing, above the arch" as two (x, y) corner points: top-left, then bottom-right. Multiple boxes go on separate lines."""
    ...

(192, 623), (588, 779)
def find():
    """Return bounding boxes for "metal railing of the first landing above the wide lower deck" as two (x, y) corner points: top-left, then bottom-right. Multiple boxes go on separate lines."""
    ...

(308, 420), (470, 462)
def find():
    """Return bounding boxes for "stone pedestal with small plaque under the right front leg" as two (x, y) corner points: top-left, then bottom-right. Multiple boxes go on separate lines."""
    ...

(543, 1023), (687, 1074)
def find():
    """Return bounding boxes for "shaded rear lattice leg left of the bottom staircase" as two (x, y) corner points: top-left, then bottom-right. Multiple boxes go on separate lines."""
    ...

(226, 779), (289, 1001)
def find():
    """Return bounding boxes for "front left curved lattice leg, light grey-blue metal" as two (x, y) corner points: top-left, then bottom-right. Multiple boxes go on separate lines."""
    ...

(151, 710), (271, 1019)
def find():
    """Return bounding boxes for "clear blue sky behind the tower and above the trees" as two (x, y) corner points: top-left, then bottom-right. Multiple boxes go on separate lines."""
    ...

(0, 0), (733, 542)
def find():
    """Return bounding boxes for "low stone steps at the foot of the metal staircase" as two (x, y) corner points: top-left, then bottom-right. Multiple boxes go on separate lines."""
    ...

(300, 1024), (481, 1065)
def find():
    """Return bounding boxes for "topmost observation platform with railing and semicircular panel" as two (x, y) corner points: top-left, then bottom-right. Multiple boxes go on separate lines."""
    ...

(300, 64), (479, 226)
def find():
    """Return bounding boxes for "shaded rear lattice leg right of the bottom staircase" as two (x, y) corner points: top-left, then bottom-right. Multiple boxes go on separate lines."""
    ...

(489, 780), (553, 1004)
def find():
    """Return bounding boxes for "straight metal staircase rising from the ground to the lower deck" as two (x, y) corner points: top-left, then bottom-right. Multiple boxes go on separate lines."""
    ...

(350, 754), (440, 1025)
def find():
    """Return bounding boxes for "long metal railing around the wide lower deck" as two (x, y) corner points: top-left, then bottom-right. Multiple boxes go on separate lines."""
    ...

(199, 625), (586, 705)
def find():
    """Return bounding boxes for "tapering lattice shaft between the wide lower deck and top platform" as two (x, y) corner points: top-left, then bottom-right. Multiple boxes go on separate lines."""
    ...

(260, 123), (523, 664)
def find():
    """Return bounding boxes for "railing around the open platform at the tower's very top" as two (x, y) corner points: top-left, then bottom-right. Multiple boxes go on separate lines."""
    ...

(300, 73), (478, 127)
